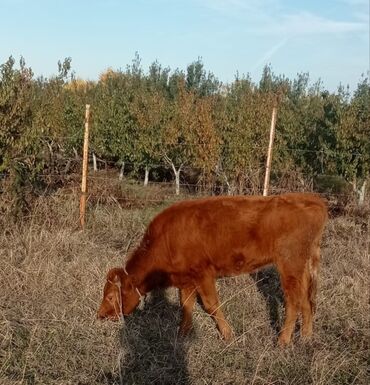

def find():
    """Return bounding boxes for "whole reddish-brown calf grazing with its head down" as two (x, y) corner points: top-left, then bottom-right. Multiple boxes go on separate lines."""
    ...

(98, 193), (327, 345)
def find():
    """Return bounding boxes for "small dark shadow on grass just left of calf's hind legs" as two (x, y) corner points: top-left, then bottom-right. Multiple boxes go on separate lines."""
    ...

(251, 267), (284, 335)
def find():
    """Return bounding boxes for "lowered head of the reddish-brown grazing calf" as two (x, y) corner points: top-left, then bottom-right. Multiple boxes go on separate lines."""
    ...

(98, 268), (140, 321)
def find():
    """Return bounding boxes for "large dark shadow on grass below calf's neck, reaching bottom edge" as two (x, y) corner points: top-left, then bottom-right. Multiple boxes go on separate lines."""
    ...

(112, 290), (189, 385)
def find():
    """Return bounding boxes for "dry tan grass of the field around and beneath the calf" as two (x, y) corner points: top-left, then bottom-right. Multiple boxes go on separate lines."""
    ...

(0, 190), (369, 385)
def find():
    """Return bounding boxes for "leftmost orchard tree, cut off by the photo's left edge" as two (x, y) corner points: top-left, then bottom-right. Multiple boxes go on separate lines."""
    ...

(0, 57), (38, 214)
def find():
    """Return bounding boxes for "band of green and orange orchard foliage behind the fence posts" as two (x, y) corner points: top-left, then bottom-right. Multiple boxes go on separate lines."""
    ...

(0, 54), (370, 207)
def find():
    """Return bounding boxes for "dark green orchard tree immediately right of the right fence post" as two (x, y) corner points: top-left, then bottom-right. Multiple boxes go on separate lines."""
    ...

(274, 73), (342, 187)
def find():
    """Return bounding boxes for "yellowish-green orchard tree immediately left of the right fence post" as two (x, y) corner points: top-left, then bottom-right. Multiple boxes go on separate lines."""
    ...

(218, 77), (273, 194)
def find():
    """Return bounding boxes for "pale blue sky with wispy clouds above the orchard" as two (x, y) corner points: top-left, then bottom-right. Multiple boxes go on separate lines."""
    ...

(0, 0), (369, 90)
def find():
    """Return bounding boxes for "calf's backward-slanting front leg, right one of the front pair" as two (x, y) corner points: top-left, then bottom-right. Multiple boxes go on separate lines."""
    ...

(198, 277), (233, 341)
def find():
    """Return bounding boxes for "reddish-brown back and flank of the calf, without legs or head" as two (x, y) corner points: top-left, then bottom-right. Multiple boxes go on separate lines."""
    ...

(146, 194), (327, 275)
